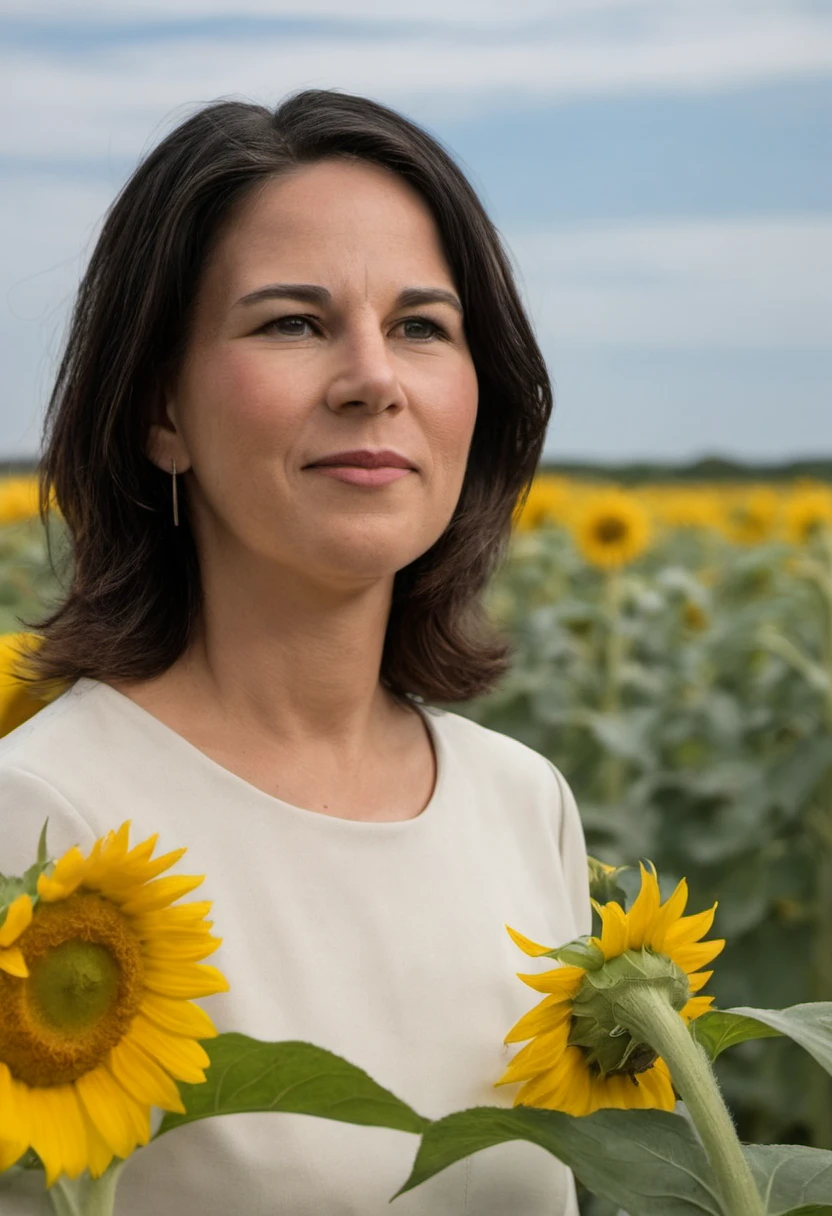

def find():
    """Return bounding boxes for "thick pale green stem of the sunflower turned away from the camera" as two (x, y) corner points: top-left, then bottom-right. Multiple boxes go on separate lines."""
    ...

(615, 985), (765, 1216)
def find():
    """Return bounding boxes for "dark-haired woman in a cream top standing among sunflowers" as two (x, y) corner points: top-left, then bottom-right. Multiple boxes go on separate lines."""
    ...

(0, 91), (589, 1216)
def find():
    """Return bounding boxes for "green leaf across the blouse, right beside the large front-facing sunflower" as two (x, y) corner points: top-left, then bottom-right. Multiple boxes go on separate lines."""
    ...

(156, 1034), (428, 1136)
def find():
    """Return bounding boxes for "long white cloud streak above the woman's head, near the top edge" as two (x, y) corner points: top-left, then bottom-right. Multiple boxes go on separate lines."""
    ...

(0, 0), (832, 161)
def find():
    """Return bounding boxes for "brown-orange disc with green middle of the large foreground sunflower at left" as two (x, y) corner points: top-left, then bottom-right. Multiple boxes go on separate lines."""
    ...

(0, 891), (144, 1086)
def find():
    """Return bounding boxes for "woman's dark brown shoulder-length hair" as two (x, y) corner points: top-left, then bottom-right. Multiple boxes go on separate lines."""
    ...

(24, 90), (552, 703)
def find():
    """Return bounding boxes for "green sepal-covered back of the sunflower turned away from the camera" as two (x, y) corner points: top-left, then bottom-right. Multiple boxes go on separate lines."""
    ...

(568, 948), (690, 1077)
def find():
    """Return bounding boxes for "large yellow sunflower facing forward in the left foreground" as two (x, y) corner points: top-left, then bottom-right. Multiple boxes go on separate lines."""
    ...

(0, 822), (227, 1186)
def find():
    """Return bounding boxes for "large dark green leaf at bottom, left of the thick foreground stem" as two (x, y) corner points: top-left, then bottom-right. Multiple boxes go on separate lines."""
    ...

(398, 1107), (723, 1216)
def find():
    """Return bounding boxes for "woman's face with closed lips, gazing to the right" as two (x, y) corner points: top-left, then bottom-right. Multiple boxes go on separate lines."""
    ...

(151, 161), (477, 587)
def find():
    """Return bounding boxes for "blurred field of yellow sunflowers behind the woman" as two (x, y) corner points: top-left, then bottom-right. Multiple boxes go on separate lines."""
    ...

(0, 473), (832, 1162)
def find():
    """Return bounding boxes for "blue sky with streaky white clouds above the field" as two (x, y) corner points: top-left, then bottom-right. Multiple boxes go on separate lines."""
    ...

(0, 0), (832, 463)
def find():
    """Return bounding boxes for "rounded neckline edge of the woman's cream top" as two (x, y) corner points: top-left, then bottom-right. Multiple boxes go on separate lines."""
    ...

(73, 676), (448, 832)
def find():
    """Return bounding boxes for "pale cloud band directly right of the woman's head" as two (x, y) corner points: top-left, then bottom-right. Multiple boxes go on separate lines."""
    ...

(510, 218), (832, 351)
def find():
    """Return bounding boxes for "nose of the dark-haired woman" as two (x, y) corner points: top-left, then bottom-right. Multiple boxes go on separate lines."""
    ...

(326, 317), (406, 413)
